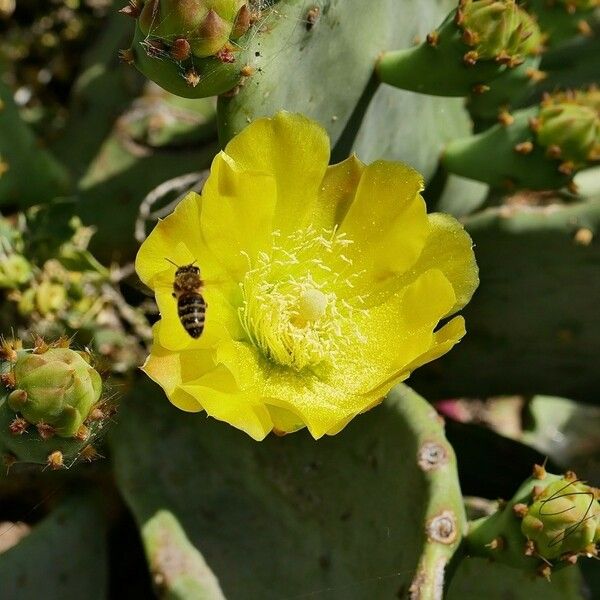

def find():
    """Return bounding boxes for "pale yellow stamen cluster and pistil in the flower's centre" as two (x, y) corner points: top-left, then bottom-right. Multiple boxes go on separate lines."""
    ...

(239, 226), (364, 371)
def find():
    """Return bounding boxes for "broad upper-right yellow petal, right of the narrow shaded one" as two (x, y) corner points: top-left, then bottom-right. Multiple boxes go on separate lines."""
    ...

(340, 161), (430, 294)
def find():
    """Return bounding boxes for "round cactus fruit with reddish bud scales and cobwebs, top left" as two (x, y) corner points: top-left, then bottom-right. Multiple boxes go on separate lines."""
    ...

(121, 0), (254, 98)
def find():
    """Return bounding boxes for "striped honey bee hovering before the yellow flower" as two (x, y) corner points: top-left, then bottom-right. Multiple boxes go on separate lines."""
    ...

(167, 259), (208, 339)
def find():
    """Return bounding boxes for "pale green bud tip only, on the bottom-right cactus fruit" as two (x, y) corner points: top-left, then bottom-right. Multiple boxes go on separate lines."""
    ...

(521, 477), (600, 560)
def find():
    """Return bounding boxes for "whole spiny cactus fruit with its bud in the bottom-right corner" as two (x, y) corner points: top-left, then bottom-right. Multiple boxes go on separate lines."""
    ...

(466, 465), (600, 577)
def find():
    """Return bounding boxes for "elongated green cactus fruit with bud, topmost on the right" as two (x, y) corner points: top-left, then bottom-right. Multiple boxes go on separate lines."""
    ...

(377, 0), (542, 96)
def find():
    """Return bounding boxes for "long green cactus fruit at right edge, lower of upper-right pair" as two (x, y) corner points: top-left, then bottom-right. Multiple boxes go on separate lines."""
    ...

(443, 89), (600, 190)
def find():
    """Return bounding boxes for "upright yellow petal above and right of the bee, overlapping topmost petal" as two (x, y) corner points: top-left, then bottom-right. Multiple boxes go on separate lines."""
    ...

(200, 153), (276, 280)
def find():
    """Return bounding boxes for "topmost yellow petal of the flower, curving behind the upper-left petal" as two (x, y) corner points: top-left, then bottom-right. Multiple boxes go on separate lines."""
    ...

(225, 111), (329, 234)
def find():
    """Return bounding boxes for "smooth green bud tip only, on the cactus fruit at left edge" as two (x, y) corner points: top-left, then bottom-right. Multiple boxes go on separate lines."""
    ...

(8, 348), (102, 437)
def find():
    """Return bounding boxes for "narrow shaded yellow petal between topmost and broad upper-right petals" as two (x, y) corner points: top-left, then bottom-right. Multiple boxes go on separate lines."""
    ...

(311, 154), (365, 230)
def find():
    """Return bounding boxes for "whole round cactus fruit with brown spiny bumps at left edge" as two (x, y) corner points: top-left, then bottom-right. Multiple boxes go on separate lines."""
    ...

(0, 338), (112, 469)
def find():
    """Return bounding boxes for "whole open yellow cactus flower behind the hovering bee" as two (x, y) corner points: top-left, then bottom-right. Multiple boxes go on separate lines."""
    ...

(136, 112), (478, 440)
